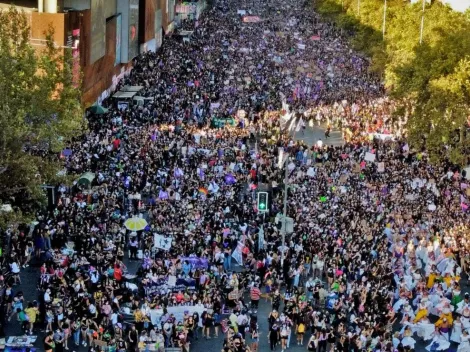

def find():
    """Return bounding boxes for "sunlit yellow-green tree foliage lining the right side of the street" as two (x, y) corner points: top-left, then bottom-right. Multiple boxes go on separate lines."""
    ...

(316, 0), (470, 164)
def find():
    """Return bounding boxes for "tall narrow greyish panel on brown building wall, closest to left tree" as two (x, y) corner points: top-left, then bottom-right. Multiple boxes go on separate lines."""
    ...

(90, 0), (106, 64)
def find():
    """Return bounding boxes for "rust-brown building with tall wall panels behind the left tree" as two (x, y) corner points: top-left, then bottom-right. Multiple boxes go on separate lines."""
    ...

(0, 0), (175, 106)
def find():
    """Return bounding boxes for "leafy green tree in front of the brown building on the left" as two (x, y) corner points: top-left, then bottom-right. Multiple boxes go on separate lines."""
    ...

(0, 7), (85, 226)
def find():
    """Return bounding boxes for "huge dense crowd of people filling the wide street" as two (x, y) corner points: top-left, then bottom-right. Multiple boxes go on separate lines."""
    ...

(1, 0), (470, 352)
